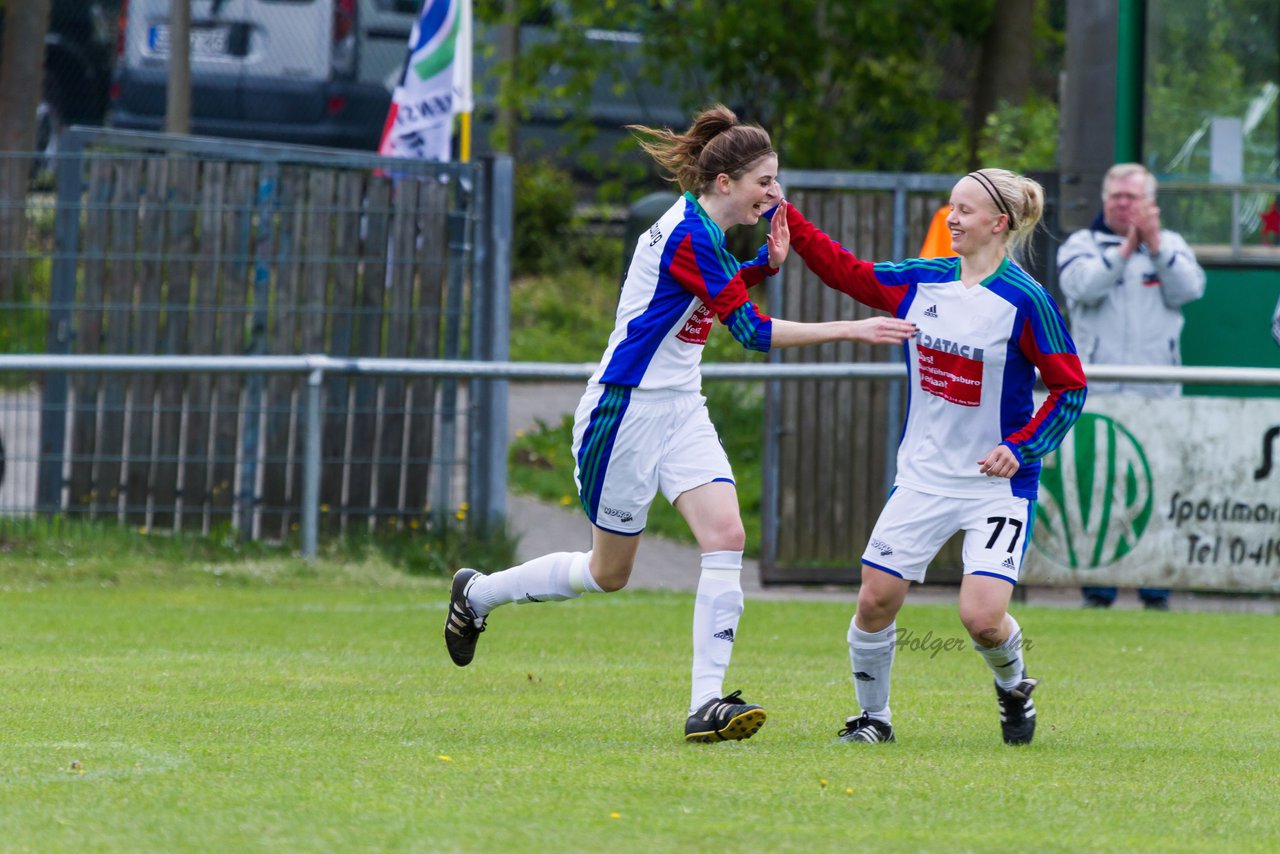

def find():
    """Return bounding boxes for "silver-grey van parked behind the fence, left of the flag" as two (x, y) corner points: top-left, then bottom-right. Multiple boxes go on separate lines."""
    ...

(108, 0), (420, 151)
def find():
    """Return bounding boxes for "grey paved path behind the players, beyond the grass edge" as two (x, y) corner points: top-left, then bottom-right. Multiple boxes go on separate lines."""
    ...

(507, 380), (1280, 613)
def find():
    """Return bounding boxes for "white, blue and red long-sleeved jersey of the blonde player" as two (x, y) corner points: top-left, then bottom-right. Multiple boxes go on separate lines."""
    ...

(787, 206), (1085, 499)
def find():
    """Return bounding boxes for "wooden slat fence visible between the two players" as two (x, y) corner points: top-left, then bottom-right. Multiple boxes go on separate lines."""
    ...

(760, 170), (957, 581)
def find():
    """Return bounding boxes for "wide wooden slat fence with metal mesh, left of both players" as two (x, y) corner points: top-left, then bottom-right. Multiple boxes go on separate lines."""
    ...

(0, 129), (512, 539)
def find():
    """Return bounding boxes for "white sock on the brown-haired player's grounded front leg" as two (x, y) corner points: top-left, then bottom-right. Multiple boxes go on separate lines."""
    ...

(689, 552), (742, 714)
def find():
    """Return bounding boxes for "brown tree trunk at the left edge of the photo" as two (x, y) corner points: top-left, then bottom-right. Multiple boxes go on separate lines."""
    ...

(0, 0), (50, 302)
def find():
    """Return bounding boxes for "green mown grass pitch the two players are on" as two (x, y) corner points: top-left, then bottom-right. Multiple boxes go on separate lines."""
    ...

(0, 550), (1280, 851)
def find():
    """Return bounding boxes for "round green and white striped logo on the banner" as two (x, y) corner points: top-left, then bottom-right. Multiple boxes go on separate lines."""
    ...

(1032, 412), (1153, 570)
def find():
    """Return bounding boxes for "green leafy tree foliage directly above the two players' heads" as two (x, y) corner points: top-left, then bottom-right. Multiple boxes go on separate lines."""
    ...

(646, 0), (992, 170)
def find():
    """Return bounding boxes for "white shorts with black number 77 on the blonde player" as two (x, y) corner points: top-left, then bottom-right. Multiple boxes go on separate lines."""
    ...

(863, 487), (1036, 584)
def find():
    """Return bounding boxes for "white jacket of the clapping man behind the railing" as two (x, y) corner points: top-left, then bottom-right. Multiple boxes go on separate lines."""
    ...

(1057, 215), (1204, 394)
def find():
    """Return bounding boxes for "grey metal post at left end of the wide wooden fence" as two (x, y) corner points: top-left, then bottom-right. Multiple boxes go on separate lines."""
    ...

(36, 129), (84, 513)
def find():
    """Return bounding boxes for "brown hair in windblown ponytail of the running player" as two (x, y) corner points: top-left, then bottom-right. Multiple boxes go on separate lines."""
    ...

(627, 104), (773, 193)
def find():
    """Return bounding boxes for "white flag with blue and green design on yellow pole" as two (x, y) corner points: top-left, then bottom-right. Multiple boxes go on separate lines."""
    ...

(378, 0), (472, 160)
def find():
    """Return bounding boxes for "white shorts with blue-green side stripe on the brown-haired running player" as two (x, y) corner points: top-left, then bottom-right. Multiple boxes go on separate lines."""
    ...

(573, 384), (733, 535)
